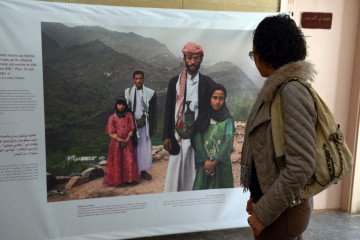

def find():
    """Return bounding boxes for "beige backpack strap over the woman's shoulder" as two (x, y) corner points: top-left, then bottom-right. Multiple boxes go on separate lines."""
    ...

(271, 77), (309, 172)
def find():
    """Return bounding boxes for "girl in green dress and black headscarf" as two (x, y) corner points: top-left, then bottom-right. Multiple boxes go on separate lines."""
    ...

(193, 84), (235, 190)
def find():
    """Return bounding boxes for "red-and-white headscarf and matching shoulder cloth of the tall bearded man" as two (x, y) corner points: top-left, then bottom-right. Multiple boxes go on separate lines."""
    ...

(175, 42), (204, 142)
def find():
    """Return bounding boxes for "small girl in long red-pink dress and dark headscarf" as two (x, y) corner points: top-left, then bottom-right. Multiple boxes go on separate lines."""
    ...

(103, 97), (140, 187)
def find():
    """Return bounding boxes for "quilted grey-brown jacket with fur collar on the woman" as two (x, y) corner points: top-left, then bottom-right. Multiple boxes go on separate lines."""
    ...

(243, 61), (317, 226)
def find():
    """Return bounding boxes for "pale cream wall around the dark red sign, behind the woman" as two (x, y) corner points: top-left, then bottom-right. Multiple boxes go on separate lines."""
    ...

(281, 0), (360, 210)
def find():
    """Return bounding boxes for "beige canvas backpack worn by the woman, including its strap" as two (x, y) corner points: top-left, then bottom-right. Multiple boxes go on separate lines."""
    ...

(271, 78), (353, 198)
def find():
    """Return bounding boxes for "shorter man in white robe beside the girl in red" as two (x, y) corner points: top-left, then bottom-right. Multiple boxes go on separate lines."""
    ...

(125, 70), (157, 180)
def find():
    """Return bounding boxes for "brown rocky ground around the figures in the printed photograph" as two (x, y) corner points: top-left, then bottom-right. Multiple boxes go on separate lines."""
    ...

(48, 122), (245, 202)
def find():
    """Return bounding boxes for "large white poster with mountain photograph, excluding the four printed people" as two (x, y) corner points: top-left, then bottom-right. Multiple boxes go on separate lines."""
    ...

(0, 0), (268, 239)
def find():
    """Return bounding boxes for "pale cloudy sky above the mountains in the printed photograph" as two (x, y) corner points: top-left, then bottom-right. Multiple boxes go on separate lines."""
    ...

(67, 24), (264, 87)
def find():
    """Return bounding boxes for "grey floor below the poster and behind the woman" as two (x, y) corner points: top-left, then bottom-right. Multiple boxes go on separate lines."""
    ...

(132, 211), (360, 240)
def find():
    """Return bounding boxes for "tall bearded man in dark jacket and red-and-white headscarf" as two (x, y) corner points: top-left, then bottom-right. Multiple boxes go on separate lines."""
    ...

(163, 42), (215, 192)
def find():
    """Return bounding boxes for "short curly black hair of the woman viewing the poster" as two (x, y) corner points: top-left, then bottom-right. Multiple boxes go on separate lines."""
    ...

(253, 14), (307, 69)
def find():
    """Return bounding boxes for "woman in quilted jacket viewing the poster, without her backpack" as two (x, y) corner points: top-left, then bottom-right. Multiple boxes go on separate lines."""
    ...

(240, 14), (317, 240)
